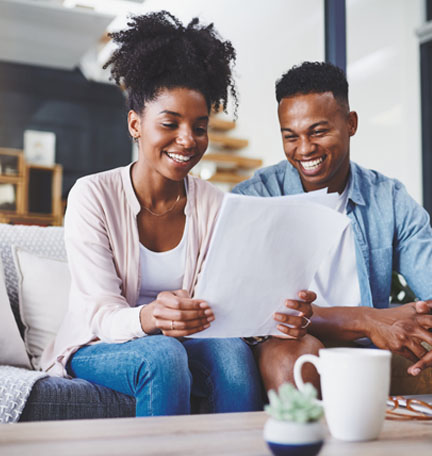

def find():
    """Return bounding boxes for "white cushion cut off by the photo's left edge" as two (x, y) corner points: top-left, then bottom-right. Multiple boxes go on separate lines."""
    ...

(0, 256), (30, 368)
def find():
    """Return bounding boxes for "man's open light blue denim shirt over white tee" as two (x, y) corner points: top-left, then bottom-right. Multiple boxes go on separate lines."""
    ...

(233, 160), (432, 308)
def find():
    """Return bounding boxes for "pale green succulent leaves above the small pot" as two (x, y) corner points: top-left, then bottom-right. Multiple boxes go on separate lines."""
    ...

(265, 383), (323, 423)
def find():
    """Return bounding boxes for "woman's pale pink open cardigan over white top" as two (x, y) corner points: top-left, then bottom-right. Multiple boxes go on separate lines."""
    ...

(41, 165), (223, 377)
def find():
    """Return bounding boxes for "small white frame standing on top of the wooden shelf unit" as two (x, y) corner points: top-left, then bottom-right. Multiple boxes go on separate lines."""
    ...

(24, 130), (55, 166)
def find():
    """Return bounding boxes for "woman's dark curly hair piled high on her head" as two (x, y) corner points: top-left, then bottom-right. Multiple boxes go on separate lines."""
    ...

(104, 11), (237, 112)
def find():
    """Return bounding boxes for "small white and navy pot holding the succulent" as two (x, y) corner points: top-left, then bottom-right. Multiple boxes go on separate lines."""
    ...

(264, 418), (324, 456)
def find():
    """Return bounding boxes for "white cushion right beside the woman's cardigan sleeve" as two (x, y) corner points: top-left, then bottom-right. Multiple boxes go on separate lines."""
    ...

(13, 247), (70, 369)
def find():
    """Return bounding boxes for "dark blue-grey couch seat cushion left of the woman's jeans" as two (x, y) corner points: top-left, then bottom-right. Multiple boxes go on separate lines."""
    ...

(20, 377), (135, 421)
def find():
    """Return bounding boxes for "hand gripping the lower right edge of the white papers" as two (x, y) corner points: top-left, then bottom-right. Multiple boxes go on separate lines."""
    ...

(273, 290), (316, 339)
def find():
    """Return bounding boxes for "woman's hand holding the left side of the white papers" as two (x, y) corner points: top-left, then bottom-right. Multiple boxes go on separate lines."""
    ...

(140, 290), (214, 337)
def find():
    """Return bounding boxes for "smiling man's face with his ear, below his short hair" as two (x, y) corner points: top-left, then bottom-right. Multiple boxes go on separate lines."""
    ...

(278, 92), (357, 193)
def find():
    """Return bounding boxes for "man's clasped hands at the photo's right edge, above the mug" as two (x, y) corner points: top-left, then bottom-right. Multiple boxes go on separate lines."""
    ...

(366, 301), (432, 375)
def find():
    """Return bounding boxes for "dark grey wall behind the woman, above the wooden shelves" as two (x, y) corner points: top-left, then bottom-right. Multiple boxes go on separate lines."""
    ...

(0, 62), (131, 197)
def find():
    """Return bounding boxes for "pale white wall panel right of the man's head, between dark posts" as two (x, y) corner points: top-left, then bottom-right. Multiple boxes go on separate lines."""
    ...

(346, 0), (424, 203)
